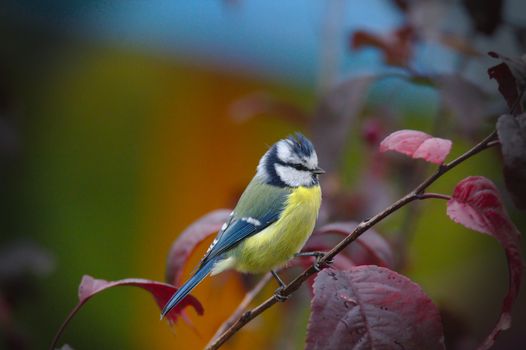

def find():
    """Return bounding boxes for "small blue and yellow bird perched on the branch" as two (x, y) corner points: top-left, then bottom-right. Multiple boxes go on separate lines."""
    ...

(161, 132), (325, 320)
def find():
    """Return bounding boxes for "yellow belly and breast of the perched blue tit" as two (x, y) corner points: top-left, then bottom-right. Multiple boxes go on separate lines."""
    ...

(230, 186), (321, 273)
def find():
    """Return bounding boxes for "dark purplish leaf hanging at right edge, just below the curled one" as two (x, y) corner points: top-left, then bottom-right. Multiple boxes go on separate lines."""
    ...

(497, 113), (526, 210)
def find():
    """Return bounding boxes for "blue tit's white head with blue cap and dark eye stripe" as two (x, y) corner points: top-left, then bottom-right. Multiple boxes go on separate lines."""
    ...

(256, 133), (324, 187)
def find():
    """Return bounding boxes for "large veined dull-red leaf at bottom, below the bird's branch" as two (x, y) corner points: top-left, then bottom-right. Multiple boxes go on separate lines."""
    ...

(306, 266), (444, 350)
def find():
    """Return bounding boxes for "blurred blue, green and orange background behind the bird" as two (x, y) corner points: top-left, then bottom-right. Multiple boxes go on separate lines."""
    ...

(0, 0), (526, 349)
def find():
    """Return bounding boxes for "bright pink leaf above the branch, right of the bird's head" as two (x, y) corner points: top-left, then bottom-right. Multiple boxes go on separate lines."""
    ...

(380, 130), (451, 164)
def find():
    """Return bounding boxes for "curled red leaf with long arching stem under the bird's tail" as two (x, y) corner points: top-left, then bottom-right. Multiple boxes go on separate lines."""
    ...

(51, 275), (204, 349)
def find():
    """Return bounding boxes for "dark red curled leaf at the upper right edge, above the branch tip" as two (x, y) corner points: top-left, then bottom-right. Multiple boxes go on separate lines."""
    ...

(488, 52), (526, 112)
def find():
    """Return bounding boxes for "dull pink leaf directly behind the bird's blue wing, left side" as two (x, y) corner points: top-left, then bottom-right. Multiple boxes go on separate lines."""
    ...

(166, 209), (231, 286)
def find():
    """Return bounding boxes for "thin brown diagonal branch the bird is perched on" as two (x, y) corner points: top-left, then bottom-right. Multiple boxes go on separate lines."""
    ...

(207, 130), (497, 350)
